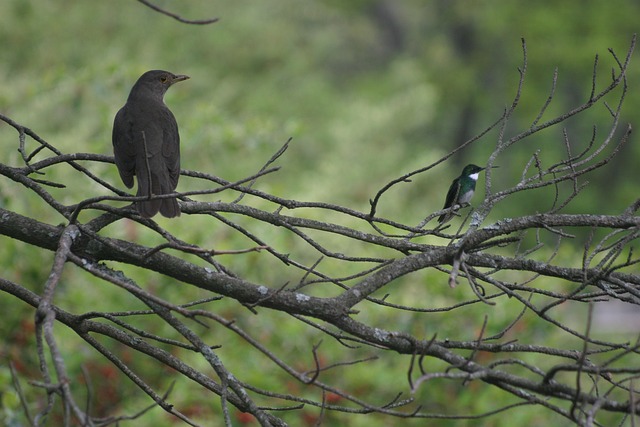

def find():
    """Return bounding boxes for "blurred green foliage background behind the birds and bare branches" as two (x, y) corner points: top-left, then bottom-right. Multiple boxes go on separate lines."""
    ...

(0, 0), (640, 426)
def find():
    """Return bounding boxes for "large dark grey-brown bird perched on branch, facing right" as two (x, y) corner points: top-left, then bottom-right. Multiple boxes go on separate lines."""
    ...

(113, 70), (189, 218)
